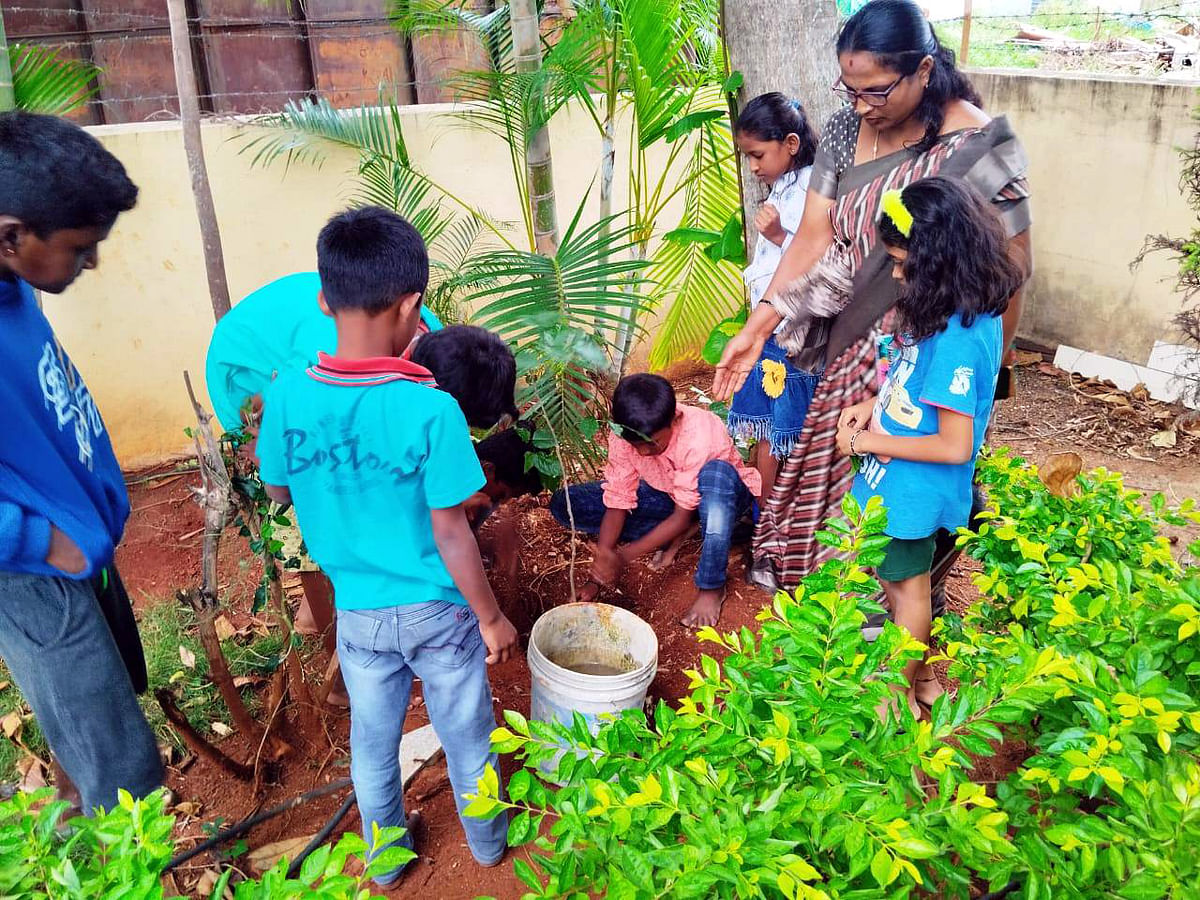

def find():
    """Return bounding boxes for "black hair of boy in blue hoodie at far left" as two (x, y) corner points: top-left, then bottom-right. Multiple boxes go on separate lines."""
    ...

(0, 112), (138, 239)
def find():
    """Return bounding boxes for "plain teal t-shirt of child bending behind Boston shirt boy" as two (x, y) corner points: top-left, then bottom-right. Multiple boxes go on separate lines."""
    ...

(204, 272), (442, 431)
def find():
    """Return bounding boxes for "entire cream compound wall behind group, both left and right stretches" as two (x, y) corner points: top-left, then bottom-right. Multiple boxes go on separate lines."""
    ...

(46, 72), (1196, 466)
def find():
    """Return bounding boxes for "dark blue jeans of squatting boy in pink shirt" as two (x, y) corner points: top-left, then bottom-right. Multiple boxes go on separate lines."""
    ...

(550, 460), (754, 590)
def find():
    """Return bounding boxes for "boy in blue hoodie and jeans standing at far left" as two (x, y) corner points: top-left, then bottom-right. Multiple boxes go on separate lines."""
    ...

(0, 112), (162, 811)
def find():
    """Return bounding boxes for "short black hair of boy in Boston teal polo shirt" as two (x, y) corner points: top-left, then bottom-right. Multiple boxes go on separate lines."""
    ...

(317, 206), (430, 314)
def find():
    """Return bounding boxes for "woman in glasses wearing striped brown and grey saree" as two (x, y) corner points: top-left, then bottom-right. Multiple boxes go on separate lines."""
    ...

(713, 0), (1031, 588)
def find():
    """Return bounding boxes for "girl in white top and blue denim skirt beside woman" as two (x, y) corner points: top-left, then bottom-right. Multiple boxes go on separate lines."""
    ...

(730, 92), (821, 497)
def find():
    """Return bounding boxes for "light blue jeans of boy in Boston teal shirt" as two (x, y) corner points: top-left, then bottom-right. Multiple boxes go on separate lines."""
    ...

(337, 600), (509, 884)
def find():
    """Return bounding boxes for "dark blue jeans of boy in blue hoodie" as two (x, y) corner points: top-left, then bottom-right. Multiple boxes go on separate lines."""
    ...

(0, 572), (162, 812)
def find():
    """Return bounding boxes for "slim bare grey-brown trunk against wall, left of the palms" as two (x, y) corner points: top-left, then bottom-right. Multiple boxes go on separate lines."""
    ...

(167, 0), (229, 319)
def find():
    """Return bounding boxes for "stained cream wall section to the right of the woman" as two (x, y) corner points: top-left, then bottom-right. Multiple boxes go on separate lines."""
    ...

(973, 72), (1198, 364)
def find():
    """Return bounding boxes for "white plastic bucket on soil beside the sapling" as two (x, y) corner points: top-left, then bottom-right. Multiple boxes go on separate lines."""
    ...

(527, 604), (659, 731)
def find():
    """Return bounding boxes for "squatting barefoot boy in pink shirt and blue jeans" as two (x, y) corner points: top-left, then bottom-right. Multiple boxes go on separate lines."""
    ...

(550, 374), (762, 628)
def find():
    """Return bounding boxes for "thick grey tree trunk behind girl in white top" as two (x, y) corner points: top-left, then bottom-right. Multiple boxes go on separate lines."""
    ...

(721, 0), (840, 254)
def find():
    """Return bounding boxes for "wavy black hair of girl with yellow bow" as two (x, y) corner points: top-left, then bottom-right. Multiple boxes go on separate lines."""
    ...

(880, 178), (1025, 341)
